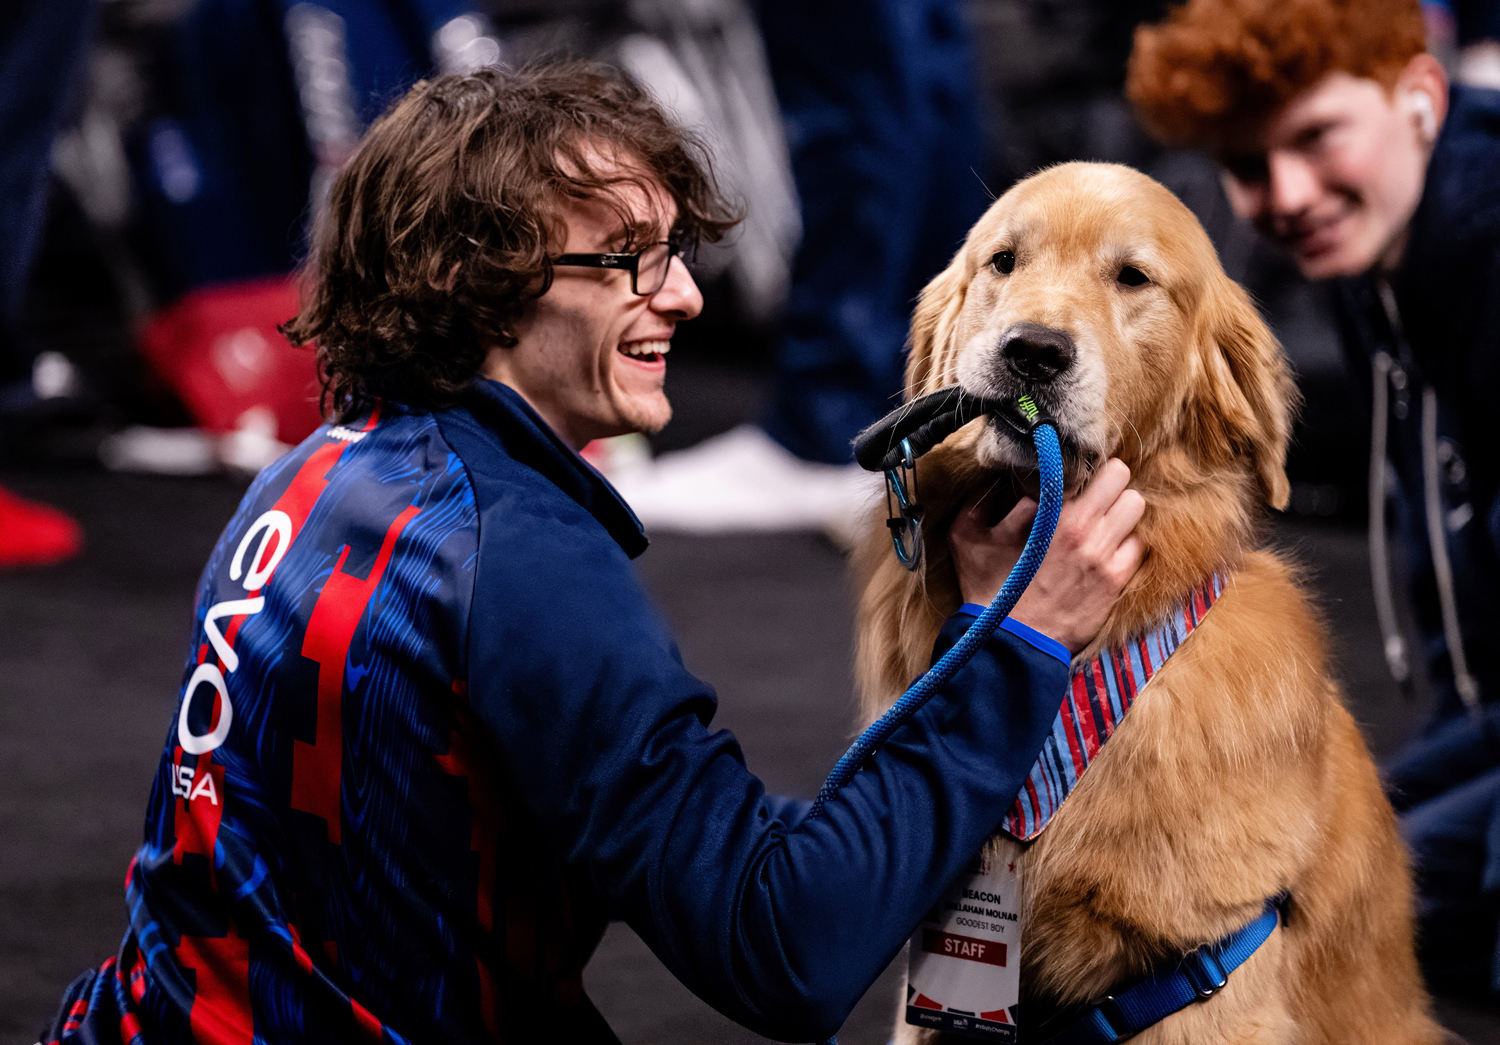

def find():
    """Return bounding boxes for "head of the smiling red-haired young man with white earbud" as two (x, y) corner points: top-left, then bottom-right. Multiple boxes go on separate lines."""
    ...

(1127, 0), (1449, 279)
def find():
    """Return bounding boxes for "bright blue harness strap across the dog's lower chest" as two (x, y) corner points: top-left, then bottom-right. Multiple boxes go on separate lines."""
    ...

(1044, 897), (1286, 1045)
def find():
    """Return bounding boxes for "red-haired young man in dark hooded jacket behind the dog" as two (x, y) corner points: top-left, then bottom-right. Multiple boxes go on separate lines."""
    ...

(1128, 0), (1500, 993)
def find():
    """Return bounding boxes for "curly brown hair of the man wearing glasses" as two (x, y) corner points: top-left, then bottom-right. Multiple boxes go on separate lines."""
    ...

(282, 61), (735, 421)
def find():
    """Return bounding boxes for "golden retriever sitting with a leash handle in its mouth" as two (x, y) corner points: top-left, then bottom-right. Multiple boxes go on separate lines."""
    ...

(855, 163), (1445, 1045)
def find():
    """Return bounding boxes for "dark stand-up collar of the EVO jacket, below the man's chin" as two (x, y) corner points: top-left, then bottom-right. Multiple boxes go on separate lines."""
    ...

(461, 378), (650, 559)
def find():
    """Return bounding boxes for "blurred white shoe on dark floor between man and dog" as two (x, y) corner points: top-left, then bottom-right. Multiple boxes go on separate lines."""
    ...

(609, 424), (881, 536)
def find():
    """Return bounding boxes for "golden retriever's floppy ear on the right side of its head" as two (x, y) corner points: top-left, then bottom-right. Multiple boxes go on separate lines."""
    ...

(1187, 274), (1298, 508)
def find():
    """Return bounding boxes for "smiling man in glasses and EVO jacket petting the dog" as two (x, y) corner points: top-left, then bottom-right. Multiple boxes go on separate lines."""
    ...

(42, 64), (1143, 1045)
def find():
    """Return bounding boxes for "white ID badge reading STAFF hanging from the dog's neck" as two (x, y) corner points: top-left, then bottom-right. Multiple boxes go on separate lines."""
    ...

(906, 837), (1022, 1042)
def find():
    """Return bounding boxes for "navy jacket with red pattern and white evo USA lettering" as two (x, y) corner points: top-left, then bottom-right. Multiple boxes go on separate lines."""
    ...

(42, 381), (1068, 1044)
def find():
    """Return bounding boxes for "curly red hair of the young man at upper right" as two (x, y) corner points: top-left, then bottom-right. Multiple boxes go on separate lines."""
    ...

(1125, 0), (1427, 148)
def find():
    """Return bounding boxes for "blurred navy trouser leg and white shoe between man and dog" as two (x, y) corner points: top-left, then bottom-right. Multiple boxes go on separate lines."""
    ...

(620, 0), (990, 535)
